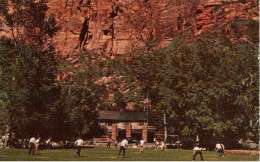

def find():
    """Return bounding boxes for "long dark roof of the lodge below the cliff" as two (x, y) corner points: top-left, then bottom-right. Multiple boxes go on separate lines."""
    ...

(98, 111), (147, 121)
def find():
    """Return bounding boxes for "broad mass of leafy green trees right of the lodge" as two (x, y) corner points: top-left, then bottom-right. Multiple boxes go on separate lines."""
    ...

(126, 36), (259, 146)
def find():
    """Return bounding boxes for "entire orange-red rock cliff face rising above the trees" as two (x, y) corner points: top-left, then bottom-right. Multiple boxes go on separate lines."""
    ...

(0, 0), (259, 57)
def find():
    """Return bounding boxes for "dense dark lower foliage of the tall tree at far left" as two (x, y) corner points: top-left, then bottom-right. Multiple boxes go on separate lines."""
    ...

(0, 38), (57, 135)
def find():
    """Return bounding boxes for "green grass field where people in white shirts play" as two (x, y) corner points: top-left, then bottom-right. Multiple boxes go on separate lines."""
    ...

(0, 148), (259, 161)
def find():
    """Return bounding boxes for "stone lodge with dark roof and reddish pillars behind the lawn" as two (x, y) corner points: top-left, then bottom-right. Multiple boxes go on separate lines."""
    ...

(98, 111), (155, 142)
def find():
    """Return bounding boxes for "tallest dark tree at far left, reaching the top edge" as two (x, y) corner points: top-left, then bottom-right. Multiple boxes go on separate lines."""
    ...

(0, 0), (59, 136)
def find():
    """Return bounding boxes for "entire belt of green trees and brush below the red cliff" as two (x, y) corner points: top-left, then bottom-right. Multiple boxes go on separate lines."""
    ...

(0, 0), (259, 147)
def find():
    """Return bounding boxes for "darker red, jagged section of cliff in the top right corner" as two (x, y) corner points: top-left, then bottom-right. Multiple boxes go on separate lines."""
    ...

(195, 0), (259, 36)
